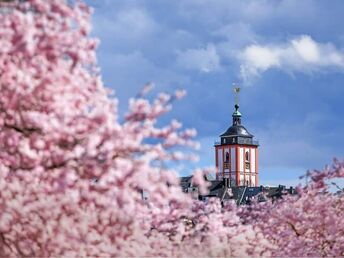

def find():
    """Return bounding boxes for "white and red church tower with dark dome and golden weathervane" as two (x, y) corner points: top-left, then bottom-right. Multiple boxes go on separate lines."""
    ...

(215, 87), (259, 186)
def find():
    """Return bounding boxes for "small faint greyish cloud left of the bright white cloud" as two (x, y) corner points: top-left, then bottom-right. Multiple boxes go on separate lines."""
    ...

(177, 44), (220, 73)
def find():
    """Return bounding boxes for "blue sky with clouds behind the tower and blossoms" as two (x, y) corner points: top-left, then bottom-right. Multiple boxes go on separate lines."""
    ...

(86, 0), (344, 185)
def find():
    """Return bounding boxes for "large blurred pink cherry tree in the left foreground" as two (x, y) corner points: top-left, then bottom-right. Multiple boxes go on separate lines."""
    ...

(0, 0), (264, 257)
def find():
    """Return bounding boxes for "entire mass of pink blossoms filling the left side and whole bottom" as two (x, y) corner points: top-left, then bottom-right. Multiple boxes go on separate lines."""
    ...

(0, 0), (344, 257)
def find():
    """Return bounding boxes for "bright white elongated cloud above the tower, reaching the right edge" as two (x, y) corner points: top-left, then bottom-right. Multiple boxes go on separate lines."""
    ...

(238, 35), (344, 83)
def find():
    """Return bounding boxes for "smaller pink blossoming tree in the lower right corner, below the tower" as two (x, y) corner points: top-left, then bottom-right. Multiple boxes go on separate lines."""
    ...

(241, 160), (344, 257)
